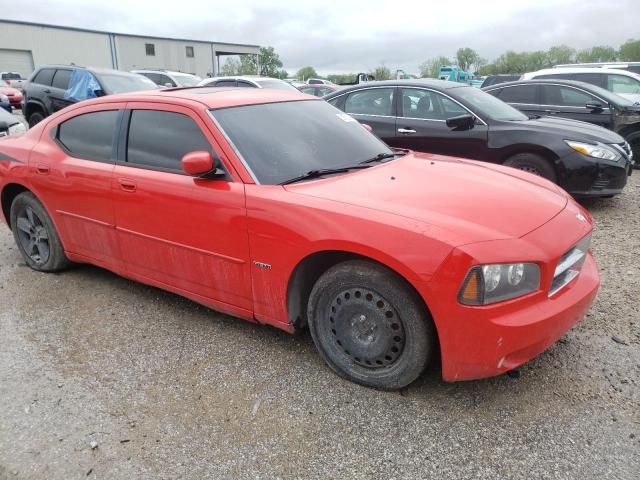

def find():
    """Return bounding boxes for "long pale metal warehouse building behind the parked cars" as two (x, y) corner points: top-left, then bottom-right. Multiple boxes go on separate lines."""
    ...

(0, 20), (260, 78)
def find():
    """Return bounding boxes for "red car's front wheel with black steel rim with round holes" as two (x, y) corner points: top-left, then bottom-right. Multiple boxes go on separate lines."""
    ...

(307, 260), (435, 390)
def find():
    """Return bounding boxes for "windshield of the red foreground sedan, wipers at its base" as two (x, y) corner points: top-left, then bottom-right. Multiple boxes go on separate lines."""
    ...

(211, 100), (393, 185)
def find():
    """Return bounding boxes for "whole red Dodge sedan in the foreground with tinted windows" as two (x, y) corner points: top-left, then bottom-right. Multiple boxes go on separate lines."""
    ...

(0, 88), (599, 388)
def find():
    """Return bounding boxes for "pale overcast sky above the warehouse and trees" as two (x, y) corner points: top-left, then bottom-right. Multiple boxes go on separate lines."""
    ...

(0, 0), (640, 75)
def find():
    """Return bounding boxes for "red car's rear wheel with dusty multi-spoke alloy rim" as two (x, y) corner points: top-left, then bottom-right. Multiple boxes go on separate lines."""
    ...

(10, 192), (71, 272)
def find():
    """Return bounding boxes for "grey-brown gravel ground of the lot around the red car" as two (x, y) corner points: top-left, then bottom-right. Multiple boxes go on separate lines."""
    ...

(0, 171), (640, 479)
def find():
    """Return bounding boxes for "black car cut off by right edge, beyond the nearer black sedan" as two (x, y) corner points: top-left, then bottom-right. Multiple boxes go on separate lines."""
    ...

(483, 80), (640, 162)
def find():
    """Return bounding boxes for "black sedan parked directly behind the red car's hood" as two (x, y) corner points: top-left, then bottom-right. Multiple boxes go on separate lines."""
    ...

(323, 80), (632, 197)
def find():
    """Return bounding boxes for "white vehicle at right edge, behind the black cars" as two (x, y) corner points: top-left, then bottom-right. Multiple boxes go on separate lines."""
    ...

(521, 67), (640, 103)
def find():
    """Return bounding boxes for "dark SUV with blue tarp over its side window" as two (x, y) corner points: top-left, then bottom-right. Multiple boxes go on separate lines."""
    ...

(23, 65), (158, 127)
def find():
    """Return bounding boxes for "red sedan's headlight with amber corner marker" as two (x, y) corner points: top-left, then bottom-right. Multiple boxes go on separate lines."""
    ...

(458, 263), (540, 305)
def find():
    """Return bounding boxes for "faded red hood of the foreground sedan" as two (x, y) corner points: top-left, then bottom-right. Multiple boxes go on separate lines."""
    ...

(284, 153), (568, 246)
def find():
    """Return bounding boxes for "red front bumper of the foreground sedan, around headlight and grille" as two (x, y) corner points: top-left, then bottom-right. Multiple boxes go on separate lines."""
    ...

(427, 202), (600, 382)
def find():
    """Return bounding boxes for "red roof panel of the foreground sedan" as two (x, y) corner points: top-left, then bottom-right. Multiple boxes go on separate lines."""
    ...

(82, 86), (321, 109)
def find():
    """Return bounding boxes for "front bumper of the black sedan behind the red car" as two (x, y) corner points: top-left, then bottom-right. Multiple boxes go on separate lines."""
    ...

(559, 151), (633, 197)
